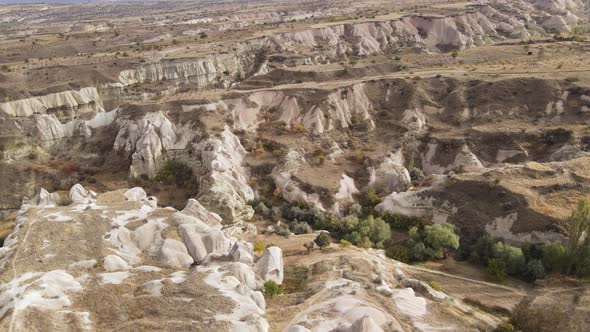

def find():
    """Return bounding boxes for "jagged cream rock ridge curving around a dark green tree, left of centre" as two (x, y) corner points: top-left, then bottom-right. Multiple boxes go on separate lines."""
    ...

(113, 112), (254, 224)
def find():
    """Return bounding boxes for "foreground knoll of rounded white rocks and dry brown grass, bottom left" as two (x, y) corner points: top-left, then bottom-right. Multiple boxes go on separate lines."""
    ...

(0, 185), (283, 331)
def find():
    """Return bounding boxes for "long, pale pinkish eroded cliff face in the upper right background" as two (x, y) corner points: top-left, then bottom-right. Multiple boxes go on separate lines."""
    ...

(260, 1), (581, 57)
